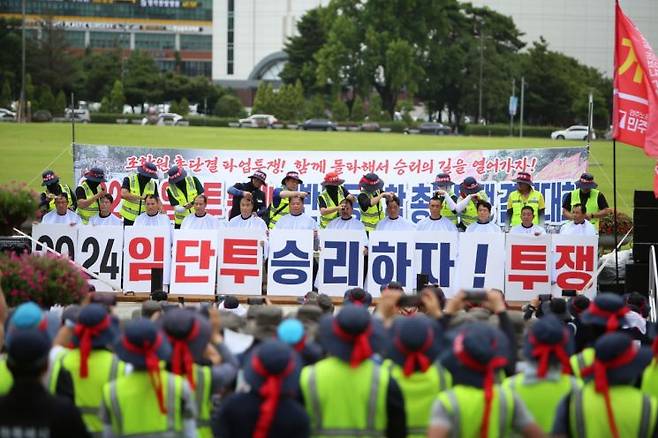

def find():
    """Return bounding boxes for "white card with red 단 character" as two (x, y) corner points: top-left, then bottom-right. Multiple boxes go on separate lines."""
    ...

(169, 230), (219, 296)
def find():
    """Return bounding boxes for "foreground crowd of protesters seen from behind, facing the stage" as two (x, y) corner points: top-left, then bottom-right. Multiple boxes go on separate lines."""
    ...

(0, 282), (658, 438)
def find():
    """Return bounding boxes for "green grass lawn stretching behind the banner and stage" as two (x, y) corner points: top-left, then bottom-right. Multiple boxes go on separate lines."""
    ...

(0, 123), (655, 213)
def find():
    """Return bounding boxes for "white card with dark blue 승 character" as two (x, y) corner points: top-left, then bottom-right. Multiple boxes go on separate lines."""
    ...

(267, 229), (313, 296)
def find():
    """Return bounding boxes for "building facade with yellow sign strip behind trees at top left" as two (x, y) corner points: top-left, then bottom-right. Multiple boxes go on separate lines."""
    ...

(0, 0), (212, 77)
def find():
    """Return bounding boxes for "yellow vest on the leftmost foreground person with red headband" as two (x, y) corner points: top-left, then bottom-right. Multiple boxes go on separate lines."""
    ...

(60, 349), (126, 432)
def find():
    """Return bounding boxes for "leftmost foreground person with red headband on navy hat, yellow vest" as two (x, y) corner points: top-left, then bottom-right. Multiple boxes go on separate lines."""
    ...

(60, 304), (125, 433)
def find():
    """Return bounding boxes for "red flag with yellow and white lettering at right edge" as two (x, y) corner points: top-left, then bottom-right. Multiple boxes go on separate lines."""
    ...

(612, 1), (658, 198)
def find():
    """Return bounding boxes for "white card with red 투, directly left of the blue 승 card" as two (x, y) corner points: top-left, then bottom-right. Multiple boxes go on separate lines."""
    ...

(217, 228), (267, 295)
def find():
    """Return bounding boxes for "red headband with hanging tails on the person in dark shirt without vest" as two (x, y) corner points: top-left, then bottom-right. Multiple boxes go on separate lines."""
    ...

(251, 354), (295, 438)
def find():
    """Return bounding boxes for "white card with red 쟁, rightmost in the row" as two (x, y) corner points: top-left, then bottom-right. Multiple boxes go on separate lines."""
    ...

(552, 234), (599, 298)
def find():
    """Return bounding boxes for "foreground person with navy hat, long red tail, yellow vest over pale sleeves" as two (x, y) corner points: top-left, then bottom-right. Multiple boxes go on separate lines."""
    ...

(427, 322), (544, 438)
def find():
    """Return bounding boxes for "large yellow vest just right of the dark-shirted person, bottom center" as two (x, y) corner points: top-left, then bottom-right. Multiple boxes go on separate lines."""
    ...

(300, 357), (386, 437)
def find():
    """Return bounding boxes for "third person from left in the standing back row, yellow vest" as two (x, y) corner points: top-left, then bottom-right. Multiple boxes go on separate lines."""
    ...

(121, 161), (158, 226)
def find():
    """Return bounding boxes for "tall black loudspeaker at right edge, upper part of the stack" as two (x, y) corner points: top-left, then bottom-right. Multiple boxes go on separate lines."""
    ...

(627, 190), (658, 264)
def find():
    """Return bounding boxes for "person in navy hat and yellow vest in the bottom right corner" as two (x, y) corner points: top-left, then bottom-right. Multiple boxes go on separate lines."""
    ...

(551, 333), (658, 438)
